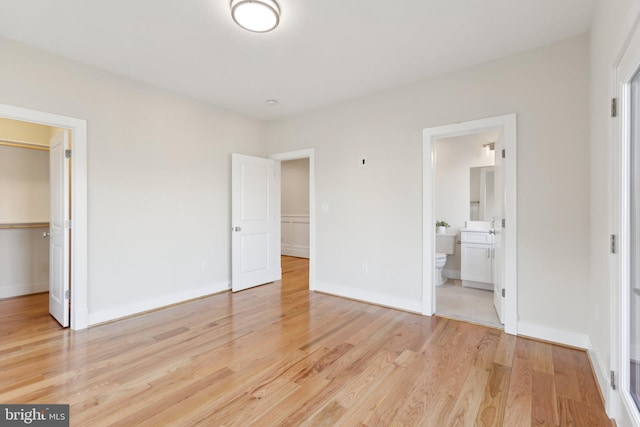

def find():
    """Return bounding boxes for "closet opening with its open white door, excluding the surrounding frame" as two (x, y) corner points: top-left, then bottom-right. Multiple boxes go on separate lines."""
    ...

(0, 118), (71, 327)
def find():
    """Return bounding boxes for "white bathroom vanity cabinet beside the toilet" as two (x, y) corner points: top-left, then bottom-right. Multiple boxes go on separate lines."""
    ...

(460, 229), (495, 290)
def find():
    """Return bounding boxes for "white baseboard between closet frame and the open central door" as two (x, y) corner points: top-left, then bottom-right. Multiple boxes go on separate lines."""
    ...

(89, 283), (230, 325)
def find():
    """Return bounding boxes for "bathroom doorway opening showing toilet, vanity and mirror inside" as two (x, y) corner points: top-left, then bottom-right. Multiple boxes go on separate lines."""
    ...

(433, 129), (502, 328)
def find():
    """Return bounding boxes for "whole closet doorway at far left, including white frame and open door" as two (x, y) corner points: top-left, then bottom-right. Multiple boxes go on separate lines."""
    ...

(0, 104), (88, 329)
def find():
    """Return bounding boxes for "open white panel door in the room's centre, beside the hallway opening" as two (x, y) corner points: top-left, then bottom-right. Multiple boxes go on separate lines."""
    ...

(231, 154), (282, 292)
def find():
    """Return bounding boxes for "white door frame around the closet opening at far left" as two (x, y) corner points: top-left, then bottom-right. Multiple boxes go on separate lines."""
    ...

(0, 104), (89, 330)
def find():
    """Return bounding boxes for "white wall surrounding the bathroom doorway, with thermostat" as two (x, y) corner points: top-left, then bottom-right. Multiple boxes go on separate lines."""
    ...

(267, 36), (589, 334)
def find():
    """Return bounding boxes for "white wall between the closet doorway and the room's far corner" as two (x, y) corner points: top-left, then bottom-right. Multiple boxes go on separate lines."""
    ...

(0, 39), (265, 323)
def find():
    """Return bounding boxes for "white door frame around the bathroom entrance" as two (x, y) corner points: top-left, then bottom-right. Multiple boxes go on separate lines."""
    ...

(422, 114), (518, 335)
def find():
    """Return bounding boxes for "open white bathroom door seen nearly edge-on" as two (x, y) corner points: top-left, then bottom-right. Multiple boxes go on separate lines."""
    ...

(493, 133), (506, 324)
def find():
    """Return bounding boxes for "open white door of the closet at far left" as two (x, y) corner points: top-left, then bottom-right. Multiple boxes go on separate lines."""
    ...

(49, 130), (70, 327)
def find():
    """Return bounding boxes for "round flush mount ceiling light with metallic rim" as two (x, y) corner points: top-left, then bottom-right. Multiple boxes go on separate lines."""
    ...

(231, 0), (280, 33)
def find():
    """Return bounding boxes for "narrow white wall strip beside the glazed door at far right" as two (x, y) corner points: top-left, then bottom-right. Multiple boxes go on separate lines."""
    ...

(588, 0), (635, 418)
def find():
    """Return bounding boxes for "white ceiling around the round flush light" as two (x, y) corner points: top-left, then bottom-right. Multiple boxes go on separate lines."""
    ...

(0, 0), (597, 119)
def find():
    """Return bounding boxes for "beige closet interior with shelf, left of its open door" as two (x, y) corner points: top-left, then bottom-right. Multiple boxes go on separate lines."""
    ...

(0, 119), (57, 298)
